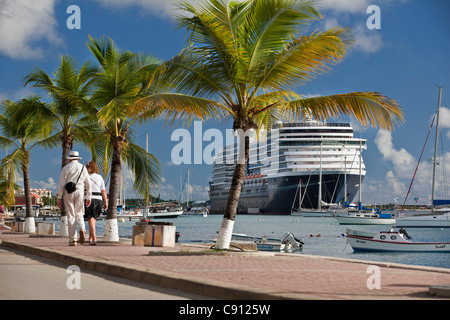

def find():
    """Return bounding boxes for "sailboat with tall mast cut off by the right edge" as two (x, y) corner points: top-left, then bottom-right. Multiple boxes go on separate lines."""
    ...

(397, 87), (450, 228)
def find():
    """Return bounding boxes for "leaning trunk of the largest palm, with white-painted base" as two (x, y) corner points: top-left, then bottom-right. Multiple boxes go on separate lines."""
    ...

(216, 136), (250, 250)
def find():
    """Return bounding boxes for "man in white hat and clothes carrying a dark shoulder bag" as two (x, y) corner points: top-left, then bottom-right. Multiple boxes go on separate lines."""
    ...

(58, 151), (91, 246)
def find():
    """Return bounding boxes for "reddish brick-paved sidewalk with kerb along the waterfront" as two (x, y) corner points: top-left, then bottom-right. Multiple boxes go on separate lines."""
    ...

(0, 230), (450, 300)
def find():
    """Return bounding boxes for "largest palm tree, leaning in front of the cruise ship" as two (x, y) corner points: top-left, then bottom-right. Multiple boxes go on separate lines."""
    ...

(161, 0), (403, 249)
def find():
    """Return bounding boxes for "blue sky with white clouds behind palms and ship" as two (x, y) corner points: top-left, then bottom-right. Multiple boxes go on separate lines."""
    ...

(0, 0), (450, 203)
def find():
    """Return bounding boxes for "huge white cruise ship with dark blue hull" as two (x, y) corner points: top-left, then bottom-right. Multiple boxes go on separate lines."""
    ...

(209, 119), (367, 215)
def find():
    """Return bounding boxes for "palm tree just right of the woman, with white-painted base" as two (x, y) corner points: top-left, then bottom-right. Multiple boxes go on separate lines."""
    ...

(87, 37), (216, 241)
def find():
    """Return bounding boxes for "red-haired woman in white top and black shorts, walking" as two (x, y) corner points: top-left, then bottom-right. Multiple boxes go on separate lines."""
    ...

(85, 161), (108, 245)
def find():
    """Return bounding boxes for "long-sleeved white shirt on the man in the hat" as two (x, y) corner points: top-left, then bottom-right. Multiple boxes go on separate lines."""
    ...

(58, 160), (92, 200)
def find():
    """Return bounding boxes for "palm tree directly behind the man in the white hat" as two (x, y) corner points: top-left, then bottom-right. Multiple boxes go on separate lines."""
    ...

(24, 56), (98, 235)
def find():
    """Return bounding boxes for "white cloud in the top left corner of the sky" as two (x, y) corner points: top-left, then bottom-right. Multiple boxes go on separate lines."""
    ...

(0, 0), (62, 59)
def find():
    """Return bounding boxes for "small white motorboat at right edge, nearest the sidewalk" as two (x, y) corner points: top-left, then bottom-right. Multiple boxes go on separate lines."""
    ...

(346, 228), (450, 252)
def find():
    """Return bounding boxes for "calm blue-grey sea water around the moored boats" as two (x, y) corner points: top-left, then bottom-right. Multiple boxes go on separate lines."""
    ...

(49, 215), (450, 268)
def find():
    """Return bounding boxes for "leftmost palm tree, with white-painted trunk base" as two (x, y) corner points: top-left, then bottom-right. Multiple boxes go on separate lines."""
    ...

(0, 96), (53, 233)
